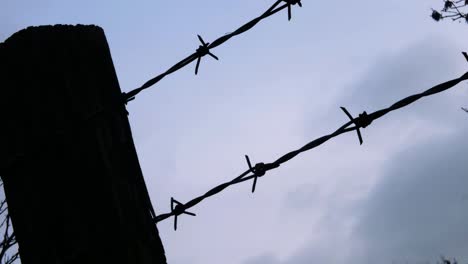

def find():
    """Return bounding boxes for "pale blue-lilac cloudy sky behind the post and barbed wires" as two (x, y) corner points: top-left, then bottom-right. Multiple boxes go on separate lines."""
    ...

(0, 0), (468, 264)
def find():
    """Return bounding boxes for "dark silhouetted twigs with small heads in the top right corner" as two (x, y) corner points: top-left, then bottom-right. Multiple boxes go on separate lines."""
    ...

(431, 0), (468, 23)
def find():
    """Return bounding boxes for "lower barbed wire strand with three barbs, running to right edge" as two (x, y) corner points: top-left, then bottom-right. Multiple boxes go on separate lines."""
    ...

(154, 68), (468, 230)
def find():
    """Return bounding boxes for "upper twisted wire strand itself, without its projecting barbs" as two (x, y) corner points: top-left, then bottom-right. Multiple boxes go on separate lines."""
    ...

(123, 0), (298, 103)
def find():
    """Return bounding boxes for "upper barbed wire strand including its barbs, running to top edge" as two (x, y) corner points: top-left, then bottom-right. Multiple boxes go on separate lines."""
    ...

(122, 0), (302, 103)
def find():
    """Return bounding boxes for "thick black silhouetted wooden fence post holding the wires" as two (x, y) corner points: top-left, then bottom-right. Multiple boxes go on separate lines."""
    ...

(0, 25), (166, 264)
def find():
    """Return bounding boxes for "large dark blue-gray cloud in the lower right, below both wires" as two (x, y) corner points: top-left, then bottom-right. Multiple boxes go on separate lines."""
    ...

(245, 120), (468, 264)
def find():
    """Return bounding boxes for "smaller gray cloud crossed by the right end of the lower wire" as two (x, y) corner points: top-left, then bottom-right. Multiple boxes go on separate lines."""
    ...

(342, 36), (467, 124)
